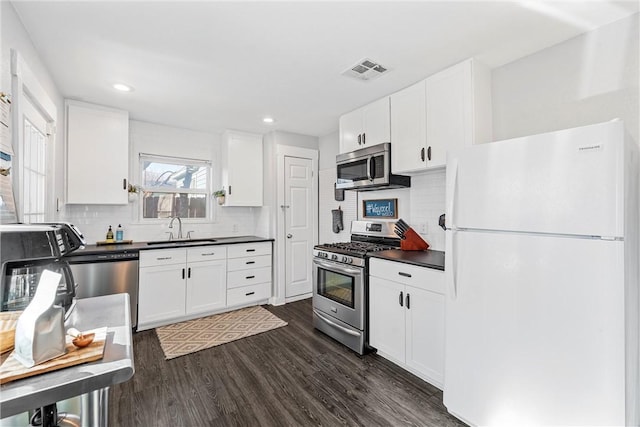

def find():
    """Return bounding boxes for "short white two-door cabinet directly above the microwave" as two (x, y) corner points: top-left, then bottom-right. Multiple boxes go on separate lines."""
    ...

(340, 96), (391, 153)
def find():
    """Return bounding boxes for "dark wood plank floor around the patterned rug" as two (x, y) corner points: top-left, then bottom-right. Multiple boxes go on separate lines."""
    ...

(109, 299), (463, 426)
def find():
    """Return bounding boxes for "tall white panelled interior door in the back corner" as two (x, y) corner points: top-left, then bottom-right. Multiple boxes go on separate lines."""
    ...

(284, 156), (314, 298)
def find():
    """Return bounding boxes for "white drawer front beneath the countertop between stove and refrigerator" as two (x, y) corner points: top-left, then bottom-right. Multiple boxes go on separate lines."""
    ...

(369, 258), (445, 294)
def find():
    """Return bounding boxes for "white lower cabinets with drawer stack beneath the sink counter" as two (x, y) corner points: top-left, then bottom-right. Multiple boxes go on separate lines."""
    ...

(138, 242), (271, 331)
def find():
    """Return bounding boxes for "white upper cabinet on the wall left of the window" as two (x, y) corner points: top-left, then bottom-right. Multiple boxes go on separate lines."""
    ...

(65, 101), (129, 205)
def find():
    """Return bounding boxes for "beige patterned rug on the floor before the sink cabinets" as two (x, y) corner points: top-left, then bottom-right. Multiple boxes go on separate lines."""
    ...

(156, 306), (287, 360)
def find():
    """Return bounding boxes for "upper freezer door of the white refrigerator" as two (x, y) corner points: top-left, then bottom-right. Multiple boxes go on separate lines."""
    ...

(448, 122), (625, 237)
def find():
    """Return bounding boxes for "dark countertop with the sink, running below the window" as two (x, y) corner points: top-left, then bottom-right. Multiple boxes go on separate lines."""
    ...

(69, 236), (274, 257)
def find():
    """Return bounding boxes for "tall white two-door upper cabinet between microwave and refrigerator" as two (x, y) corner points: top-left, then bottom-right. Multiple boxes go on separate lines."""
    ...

(391, 59), (491, 173)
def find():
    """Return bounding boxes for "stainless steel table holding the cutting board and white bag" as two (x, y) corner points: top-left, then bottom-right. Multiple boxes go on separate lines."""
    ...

(0, 293), (134, 425)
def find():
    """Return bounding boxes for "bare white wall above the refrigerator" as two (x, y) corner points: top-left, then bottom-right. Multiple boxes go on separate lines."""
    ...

(492, 14), (640, 142)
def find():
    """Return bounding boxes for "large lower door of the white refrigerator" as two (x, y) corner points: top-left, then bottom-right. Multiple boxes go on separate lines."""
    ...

(444, 231), (625, 426)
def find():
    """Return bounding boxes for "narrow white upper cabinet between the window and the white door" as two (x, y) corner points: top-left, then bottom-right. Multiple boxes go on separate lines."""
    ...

(222, 131), (264, 206)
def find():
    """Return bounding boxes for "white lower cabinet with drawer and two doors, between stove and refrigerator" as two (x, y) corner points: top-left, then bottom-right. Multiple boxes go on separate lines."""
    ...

(369, 258), (445, 388)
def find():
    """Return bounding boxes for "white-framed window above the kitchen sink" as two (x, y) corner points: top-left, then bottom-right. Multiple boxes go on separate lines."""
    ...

(140, 154), (211, 220)
